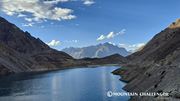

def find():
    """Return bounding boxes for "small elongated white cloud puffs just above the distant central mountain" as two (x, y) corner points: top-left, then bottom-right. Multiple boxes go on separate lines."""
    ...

(97, 29), (126, 40)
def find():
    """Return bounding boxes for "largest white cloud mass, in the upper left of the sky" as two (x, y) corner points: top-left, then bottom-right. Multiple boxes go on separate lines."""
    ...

(0, 0), (76, 22)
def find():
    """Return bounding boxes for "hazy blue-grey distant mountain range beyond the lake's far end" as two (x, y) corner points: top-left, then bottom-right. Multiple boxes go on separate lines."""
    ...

(62, 42), (131, 59)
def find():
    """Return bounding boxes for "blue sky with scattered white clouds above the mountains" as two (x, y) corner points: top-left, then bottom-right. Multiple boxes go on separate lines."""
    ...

(0, 0), (180, 51)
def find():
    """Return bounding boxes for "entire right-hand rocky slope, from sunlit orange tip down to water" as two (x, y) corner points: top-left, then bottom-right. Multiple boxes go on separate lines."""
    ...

(113, 19), (180, 101)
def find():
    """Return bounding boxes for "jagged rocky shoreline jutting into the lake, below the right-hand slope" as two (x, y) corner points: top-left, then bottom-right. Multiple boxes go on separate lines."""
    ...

(112, 64), (180, 101)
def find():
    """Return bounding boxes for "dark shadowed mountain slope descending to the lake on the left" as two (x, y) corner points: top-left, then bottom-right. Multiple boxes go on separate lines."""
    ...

(0, 17), (74, 74)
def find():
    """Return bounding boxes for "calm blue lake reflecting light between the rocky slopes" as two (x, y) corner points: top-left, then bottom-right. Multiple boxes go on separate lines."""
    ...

(0, 66), (130, 101)
